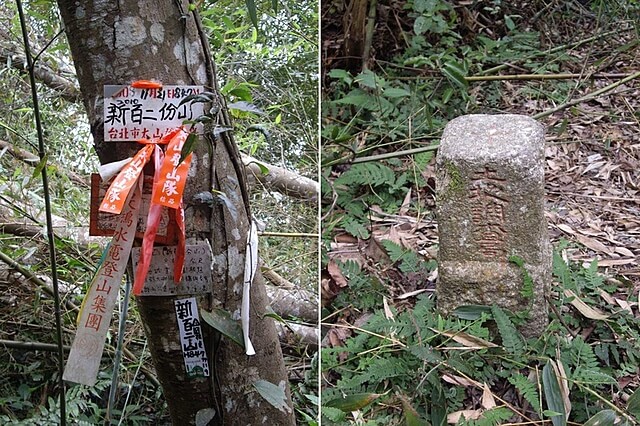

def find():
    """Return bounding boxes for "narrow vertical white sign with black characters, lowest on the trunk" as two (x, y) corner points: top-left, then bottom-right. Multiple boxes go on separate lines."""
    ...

(174, 297), (209, 377)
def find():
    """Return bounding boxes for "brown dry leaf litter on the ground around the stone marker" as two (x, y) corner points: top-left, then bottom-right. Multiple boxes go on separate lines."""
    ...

(322, 2), (640, 424)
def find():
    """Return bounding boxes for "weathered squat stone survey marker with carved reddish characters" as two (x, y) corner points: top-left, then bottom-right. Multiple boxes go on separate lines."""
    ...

(436, 115), (551, 336)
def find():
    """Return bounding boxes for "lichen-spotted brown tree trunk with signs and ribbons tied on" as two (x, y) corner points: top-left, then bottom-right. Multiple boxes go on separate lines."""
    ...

(58, 0), (295, 426)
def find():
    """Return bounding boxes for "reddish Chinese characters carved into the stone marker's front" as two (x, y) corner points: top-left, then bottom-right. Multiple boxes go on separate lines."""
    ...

(469, 167), (508, 258)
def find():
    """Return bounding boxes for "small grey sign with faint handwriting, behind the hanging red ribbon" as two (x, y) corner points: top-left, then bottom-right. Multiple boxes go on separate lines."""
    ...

(131, 244), (212, 296)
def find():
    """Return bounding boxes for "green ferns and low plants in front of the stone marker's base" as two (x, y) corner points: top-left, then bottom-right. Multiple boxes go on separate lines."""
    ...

(322, 243), (640, 426)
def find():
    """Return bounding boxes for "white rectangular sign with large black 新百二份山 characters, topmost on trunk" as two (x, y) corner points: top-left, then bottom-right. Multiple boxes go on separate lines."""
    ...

(104, 85), (204, 141)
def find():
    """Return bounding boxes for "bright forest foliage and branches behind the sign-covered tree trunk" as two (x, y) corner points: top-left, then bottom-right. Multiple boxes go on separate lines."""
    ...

(0, 0), (319, 425)
